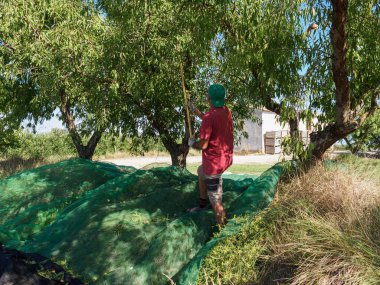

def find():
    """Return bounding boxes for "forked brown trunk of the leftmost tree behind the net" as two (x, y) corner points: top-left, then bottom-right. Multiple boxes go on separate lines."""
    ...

(60, 89), (102, 160)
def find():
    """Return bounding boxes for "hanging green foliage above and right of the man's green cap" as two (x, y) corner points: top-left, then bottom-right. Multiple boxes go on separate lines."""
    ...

(212, 1), (304, 124)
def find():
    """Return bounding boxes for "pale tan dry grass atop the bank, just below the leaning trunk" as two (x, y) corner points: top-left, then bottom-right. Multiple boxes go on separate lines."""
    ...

(276, 163), (380, 226)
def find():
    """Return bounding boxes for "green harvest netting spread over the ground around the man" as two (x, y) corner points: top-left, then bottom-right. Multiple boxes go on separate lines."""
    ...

(0, 159), (281, 284)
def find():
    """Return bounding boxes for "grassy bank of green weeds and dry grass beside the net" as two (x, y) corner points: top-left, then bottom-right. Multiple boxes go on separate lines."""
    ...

(198, 158), (380, 285)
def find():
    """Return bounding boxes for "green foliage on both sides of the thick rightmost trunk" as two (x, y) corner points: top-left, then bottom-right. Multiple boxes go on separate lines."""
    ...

(301, 0), (380, 126)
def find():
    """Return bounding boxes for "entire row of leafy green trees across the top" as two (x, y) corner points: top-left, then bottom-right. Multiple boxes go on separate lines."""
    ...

(0, 0), (380, 163)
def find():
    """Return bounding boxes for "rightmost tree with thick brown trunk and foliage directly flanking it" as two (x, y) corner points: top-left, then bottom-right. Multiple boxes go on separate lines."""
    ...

(308, 0), (380, 160)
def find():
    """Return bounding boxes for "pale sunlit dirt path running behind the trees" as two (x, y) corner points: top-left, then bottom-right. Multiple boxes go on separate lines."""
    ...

(101, 154), (283, 168)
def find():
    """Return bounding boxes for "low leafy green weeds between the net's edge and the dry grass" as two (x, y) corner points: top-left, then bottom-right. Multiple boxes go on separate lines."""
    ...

(197, 208), (286, 284)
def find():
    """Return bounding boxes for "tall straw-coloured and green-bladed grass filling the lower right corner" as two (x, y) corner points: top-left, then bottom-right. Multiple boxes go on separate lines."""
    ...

(267, 161), (380, 285)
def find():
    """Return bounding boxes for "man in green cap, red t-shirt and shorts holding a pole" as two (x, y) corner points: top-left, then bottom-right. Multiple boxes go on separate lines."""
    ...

(189, 84), (233, 225)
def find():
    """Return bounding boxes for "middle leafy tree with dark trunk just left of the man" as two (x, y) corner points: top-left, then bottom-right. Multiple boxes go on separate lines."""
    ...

(99, 0), (222, 167)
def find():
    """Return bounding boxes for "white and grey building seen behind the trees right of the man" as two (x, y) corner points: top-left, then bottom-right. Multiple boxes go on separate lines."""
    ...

(234, 109), (308, 153)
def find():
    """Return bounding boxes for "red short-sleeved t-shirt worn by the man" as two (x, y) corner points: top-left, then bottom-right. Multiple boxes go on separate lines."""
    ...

(199, 106), (234, 175)
